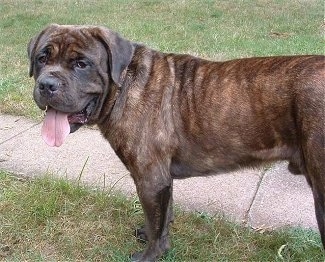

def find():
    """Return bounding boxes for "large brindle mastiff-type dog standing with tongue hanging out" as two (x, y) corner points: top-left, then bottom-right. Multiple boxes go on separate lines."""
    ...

(28, 24), (325, 261)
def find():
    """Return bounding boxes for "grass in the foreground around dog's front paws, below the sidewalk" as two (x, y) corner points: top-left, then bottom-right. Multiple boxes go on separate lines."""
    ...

(0, 172), (325, 262)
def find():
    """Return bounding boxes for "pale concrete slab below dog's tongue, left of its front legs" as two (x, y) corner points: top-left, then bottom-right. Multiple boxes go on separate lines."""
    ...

(0, 119), (134, 193)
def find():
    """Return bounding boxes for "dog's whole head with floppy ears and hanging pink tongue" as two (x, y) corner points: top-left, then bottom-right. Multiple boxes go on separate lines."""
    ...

(28, 25), (134, 146)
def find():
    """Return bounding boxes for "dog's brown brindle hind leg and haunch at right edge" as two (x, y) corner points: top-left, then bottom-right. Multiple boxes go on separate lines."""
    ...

(293, 71), (325, 248)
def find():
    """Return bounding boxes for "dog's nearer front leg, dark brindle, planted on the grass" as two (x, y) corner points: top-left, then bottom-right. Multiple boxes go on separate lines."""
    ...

(132, 165), (173, 261)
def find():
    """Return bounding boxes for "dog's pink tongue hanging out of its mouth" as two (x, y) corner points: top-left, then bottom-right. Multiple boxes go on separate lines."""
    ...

(42, 108), (70, 147)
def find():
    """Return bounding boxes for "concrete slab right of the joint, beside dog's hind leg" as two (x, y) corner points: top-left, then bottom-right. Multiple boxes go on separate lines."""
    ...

(248, 163), (317, 228)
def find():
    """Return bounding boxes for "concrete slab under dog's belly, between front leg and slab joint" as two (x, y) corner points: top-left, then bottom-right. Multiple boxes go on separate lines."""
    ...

(174, 170), (261, 223)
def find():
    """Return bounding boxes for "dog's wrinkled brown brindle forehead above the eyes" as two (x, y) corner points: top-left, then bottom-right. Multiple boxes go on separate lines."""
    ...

(38, 26), (99, 57)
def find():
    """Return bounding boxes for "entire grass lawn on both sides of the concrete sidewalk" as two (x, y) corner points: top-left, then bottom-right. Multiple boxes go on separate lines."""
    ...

(0, 0), (325, 261)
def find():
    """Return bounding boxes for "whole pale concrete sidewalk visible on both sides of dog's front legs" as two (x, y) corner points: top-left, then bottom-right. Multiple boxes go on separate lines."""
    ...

(0, 115), (317, 228)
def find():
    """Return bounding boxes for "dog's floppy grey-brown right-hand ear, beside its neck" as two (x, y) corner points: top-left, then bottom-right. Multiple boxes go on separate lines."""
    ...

(92, 27), (134, 86)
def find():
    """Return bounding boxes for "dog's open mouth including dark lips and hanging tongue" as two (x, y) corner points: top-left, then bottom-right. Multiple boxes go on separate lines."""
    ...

(42, 98), (97, 147)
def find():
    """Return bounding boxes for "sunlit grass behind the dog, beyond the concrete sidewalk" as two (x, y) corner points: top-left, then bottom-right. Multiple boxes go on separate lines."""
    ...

(0, 0), (324, 118)
